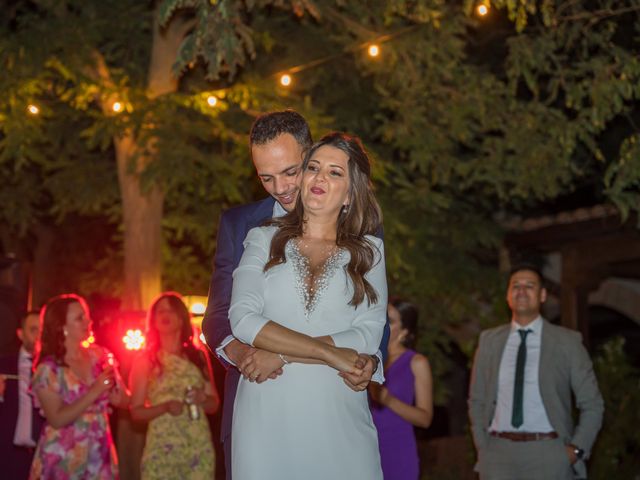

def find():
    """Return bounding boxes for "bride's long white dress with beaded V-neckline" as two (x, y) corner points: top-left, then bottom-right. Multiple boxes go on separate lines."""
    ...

(229, 227), (387, 480)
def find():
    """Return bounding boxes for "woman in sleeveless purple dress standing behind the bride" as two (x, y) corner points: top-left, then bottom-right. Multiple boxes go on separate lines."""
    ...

(369, 300), (433, 480)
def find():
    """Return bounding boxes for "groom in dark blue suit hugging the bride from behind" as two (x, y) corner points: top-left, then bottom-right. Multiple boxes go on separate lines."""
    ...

(202, 110), (388, 480)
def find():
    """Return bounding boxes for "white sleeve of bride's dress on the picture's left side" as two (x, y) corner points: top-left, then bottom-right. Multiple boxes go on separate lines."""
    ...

(229, 227), (271, 345)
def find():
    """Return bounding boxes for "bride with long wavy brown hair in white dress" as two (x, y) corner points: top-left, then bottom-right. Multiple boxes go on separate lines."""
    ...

(229, 133), (387, 480)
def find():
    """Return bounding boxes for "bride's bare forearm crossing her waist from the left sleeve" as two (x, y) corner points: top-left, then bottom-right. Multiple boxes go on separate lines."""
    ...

(253, 322), (333, 363)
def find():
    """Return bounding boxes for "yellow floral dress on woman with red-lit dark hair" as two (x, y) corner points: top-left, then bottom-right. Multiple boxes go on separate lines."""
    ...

(141, 351), (215, 480)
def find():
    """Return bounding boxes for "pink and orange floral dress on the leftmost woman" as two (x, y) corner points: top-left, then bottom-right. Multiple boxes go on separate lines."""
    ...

(29, 346), (118, 480)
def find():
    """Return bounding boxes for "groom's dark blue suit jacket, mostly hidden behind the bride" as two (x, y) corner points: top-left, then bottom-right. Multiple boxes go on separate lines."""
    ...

(202, 197), (389, 442)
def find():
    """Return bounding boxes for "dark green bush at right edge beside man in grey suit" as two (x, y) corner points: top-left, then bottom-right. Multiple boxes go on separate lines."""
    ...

(589, 337), (640, 478)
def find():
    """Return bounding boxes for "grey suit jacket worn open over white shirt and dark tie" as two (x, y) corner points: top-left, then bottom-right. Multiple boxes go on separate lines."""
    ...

(469, 320), (604, 477)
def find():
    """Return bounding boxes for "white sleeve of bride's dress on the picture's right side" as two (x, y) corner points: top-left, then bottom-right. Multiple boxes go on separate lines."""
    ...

(331, 237), (387, 355)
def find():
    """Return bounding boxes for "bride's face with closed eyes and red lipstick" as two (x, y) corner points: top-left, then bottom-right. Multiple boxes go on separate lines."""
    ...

(301, 145), (351, 217)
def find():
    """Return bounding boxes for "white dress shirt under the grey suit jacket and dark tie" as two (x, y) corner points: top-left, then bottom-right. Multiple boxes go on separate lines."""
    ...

(489, 316), (553, 433)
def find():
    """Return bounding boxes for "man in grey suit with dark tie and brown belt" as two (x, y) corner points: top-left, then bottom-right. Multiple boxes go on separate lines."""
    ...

(469, 265), (604, 480)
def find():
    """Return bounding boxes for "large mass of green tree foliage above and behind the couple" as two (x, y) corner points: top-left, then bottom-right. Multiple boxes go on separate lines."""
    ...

(0, 0), (640, 388)
